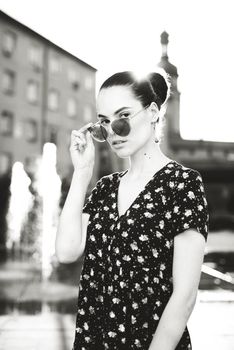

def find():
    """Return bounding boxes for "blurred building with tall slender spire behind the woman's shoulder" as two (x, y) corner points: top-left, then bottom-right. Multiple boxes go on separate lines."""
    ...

(158, 32), (234, 229)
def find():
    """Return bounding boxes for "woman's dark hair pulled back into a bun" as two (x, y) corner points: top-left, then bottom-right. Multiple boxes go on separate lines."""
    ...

(100, 71), (171, 110)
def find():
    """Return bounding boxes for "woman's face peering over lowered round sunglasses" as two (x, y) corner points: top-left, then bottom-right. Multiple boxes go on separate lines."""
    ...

(97, 86), (154, 158)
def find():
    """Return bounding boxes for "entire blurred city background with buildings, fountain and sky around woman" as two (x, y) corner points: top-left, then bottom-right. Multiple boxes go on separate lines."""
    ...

(0, 0), (234, 350)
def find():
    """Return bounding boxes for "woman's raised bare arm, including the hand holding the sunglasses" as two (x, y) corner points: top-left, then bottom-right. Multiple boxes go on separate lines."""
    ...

(55, 124), (94, 263)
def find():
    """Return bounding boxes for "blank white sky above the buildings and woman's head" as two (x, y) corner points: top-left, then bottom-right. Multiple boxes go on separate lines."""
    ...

(0, 0), (234, 142)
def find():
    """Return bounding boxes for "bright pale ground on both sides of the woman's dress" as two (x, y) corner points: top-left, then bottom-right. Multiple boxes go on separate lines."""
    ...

(0, 296), (234, 350)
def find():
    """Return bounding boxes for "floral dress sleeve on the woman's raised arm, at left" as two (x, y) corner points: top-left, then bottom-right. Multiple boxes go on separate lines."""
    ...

(83, 177), (106, 216)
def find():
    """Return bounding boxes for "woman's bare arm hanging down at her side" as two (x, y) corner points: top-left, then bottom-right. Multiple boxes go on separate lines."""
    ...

(149, 229), (205, 350)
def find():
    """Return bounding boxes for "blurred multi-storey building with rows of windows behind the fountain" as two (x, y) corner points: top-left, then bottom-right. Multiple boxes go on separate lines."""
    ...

(0, 11), (98, 178)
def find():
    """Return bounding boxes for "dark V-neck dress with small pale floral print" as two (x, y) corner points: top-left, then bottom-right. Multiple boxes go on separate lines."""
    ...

(73, 160), (208, 350)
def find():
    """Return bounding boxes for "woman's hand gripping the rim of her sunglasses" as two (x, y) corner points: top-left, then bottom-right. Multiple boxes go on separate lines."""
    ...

(70, 123), (95, 171)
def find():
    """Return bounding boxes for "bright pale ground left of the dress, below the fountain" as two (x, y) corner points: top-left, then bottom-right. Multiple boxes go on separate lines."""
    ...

(0, 313), (75, 350)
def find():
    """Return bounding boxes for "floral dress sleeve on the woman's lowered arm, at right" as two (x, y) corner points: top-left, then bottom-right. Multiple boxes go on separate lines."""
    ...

(172, 169), (209, 241)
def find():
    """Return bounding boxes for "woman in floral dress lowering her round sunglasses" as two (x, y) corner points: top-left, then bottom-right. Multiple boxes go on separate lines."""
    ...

(56, 72), (208, 350)
